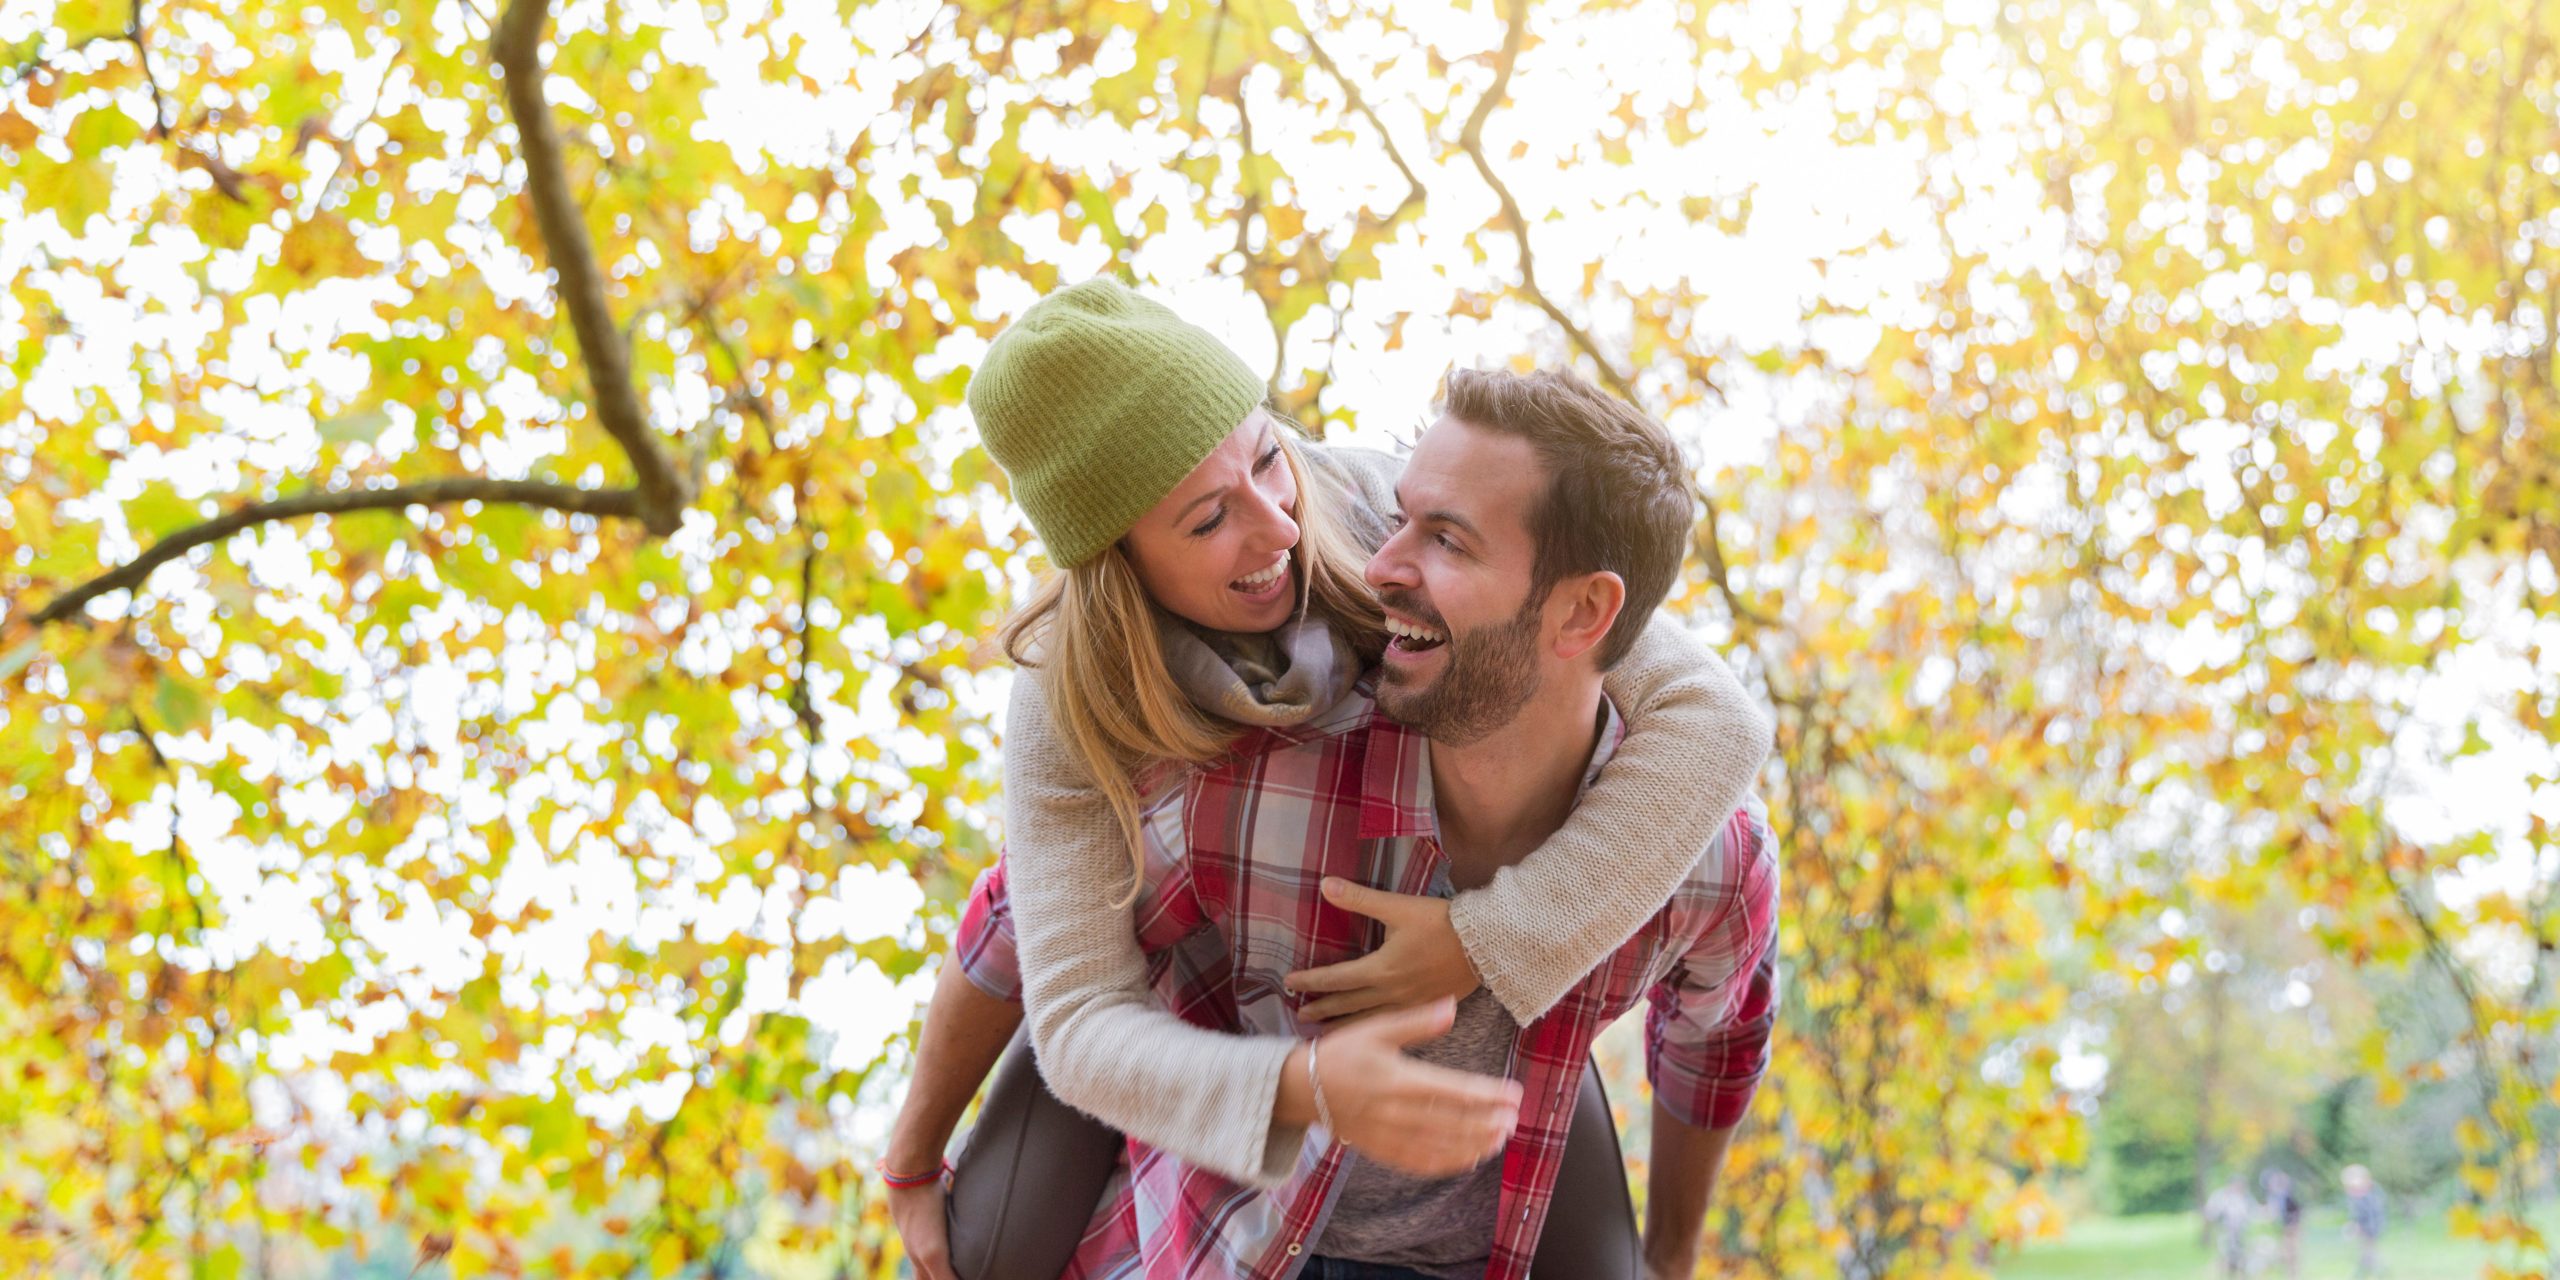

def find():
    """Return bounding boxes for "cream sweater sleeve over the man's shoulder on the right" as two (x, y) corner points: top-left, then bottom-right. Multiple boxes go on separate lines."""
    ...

(1449, 614), (1774, 1024)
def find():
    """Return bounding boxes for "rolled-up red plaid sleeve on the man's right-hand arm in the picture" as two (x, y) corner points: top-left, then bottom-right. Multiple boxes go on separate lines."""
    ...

(1644, 804), (1777, 1129)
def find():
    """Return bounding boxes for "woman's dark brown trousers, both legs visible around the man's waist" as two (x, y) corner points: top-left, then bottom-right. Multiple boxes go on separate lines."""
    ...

(947, 1034), (1641, 1280)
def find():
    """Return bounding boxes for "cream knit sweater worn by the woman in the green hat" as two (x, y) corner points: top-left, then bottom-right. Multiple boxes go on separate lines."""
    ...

(1004, 445), (1772, 1185)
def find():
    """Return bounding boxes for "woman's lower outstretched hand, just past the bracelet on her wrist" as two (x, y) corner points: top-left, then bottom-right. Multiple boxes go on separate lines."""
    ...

(1288, 998), (1521, 1178)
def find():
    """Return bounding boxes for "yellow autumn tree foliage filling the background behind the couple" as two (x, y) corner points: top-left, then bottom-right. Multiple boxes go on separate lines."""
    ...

(0, 0), (2560, 1277)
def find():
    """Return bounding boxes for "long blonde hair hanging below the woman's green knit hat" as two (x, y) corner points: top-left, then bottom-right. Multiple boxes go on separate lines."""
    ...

(996, 430), (1388, 906)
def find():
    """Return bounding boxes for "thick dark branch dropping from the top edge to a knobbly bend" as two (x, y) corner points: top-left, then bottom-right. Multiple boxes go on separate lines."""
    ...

(489, 0), (694, 538)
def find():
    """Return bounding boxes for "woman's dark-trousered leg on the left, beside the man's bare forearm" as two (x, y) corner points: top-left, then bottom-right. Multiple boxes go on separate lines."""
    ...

(950, 1034), (1126, 1280)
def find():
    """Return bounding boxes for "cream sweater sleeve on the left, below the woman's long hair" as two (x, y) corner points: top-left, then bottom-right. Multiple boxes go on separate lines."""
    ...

(983, 668), (1306, 1185)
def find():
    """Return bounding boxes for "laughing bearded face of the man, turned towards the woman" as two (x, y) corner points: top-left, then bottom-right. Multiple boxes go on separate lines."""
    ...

(1367, 417), (1546, 745)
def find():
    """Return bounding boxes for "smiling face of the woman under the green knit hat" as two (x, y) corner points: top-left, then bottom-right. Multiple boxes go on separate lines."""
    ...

(1121, 410), (1298, 632)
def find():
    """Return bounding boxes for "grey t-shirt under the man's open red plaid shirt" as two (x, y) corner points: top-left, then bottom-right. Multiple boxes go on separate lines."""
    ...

(1316, 988), (1521, 1280)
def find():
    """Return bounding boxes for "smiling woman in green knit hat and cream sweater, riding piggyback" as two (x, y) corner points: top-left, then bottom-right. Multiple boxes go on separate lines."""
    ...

(883, 282), (1769, 1275)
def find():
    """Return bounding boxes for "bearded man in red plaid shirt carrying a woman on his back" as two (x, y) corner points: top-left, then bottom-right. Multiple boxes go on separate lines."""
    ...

(926, 371), (1777, 1280)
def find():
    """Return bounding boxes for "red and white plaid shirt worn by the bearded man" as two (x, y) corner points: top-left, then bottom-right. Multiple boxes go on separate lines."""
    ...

(952, 689), (1777, 1280)
